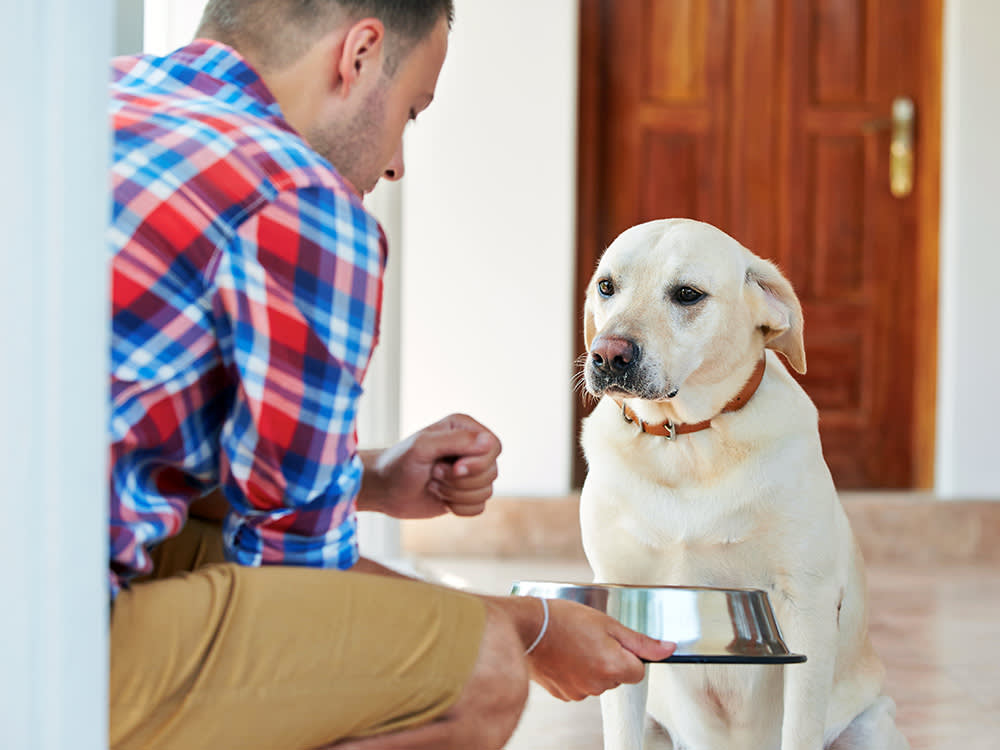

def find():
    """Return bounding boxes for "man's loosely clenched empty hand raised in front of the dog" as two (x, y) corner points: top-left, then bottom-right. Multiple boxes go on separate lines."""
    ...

(358, 414), (500, 518)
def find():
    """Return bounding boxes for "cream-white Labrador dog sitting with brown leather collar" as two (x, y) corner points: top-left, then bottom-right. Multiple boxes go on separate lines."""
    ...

(580, 219), (909, 750)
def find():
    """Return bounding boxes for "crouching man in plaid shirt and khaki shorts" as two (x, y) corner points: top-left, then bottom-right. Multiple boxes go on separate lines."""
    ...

(109, 0), (673, 750)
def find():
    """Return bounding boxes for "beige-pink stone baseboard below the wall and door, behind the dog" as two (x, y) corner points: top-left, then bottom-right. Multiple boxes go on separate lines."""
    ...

(402, 493), (1000, 564)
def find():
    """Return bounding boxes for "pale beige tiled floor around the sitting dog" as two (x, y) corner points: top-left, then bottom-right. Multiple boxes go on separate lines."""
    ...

(418, 558), (1000, 750)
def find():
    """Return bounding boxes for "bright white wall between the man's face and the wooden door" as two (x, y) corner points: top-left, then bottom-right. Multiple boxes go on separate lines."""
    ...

(401, 0), (577, 495)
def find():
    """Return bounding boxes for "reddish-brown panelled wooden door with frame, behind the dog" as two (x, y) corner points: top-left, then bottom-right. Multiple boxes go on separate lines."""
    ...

(577, 0), (941, 489)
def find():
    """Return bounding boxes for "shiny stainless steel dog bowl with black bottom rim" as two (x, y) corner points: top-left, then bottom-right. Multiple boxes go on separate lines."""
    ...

(511, 581), (806, 664)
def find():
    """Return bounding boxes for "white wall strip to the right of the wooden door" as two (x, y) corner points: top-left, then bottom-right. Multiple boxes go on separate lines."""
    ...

(937, 0), (1000, 498)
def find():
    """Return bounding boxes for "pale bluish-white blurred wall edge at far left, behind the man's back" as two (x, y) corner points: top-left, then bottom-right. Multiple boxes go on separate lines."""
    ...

(0, 0), (113, 750)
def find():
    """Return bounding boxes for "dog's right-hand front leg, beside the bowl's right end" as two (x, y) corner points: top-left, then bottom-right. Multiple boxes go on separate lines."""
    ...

(781, 597), (837, 750)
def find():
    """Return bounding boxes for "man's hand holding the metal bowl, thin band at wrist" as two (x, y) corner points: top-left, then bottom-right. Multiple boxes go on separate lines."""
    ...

(494, 596), (677, 701)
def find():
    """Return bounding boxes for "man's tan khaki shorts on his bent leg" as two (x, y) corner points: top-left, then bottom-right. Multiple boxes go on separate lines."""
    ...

(110, 520), (485, 750)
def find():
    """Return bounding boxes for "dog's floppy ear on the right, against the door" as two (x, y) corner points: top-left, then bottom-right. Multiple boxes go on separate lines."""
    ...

(746, 256), (806, 373)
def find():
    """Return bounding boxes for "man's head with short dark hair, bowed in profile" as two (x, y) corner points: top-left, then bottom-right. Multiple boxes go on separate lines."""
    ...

(198, 0), (454, 193)
